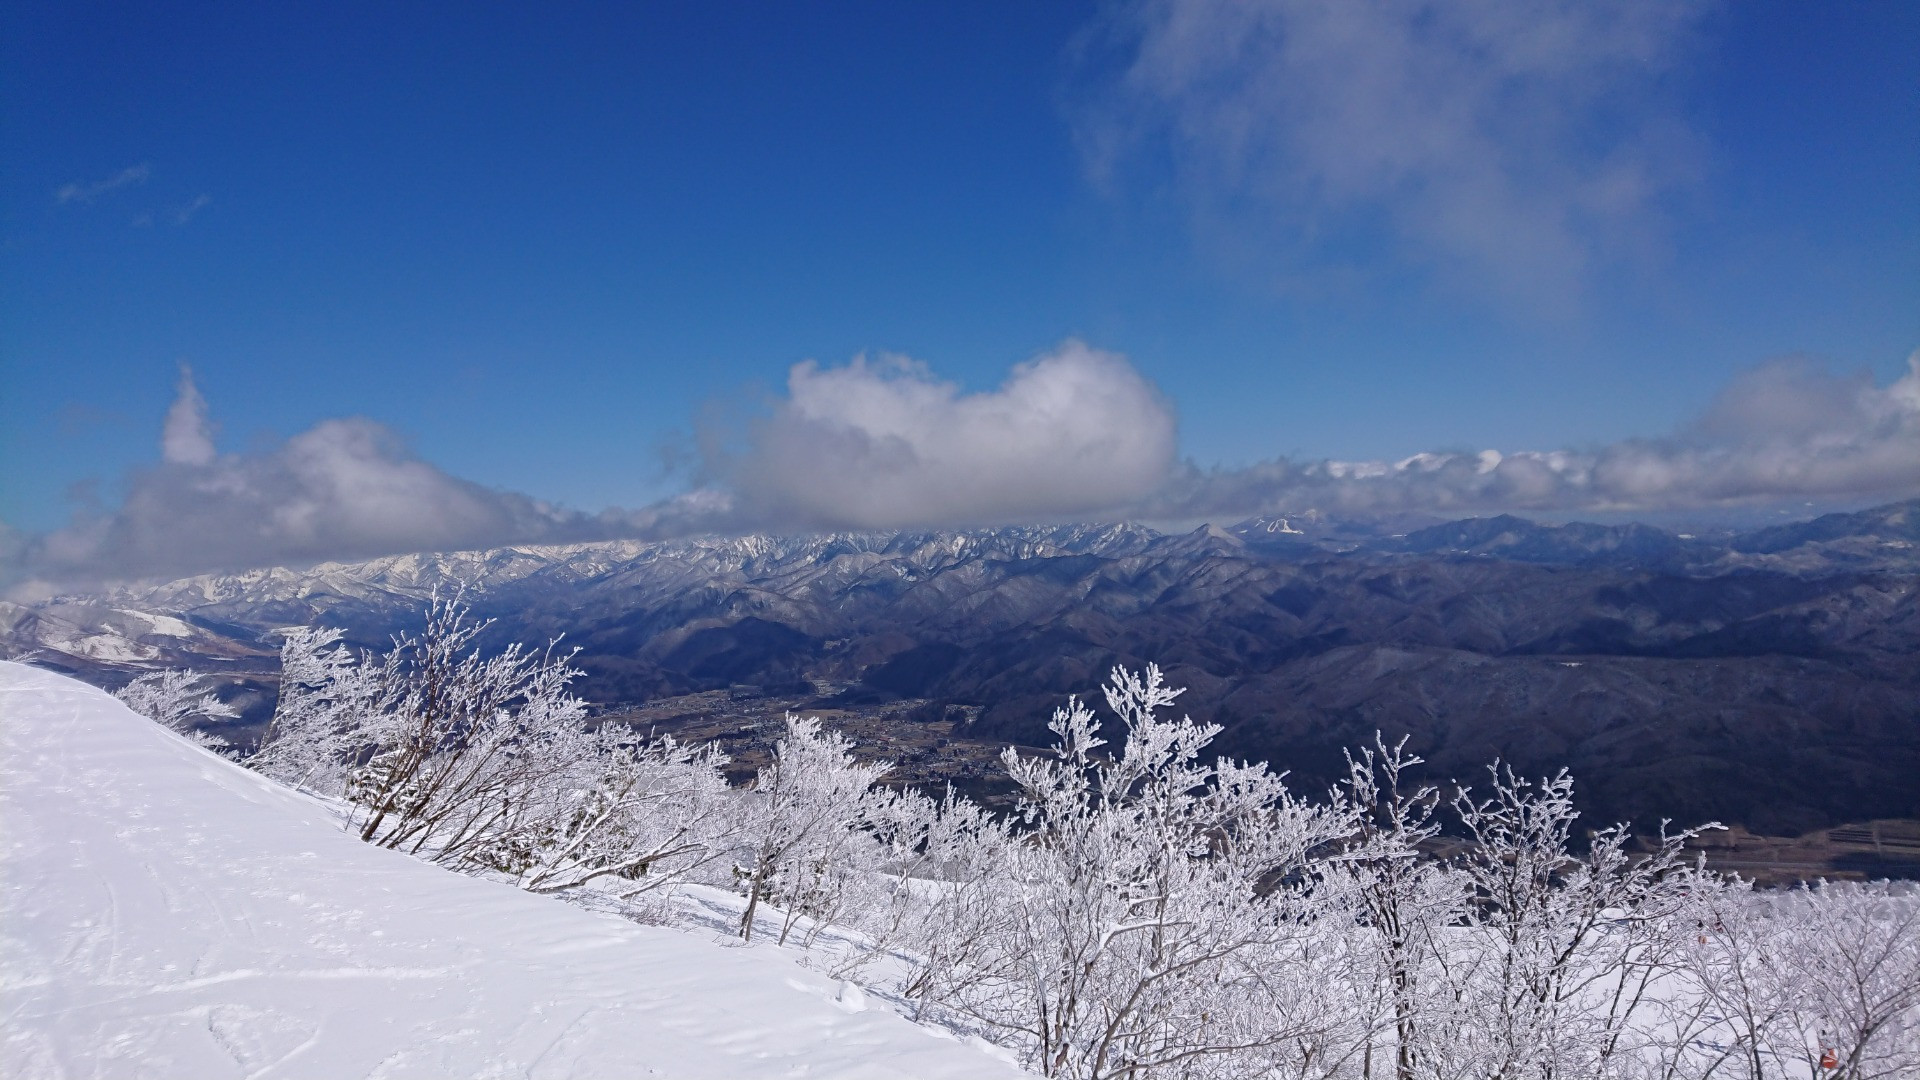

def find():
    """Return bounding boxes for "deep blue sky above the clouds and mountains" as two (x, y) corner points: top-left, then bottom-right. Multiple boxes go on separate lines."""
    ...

(0, 0), (1920, 580)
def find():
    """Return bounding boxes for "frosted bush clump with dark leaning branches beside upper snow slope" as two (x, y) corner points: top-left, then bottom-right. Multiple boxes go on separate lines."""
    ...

(250, 598), (726, 894)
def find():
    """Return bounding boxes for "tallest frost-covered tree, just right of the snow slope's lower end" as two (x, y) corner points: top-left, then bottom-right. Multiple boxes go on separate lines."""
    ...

(925, 667), (1348, 1080)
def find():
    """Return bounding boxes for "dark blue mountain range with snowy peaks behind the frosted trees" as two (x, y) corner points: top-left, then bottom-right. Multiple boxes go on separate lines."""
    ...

(0, 502), (1920, 832)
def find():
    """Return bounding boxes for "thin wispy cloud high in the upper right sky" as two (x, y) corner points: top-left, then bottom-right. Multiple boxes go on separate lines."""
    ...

(1075, 0), (1705, 306)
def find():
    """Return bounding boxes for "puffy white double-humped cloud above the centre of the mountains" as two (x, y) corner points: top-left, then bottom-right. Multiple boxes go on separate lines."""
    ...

(708, 340), (1175, 528)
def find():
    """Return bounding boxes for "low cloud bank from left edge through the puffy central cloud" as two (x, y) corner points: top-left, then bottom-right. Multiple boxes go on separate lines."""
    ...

(0, 342), (1175, 590)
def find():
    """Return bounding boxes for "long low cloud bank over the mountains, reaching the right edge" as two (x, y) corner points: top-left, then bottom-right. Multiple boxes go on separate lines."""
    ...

(1139, 352), (1920, 519)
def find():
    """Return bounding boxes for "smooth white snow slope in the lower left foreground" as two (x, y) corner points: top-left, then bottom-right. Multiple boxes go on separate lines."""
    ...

(0, 663), (1020, 1080)
